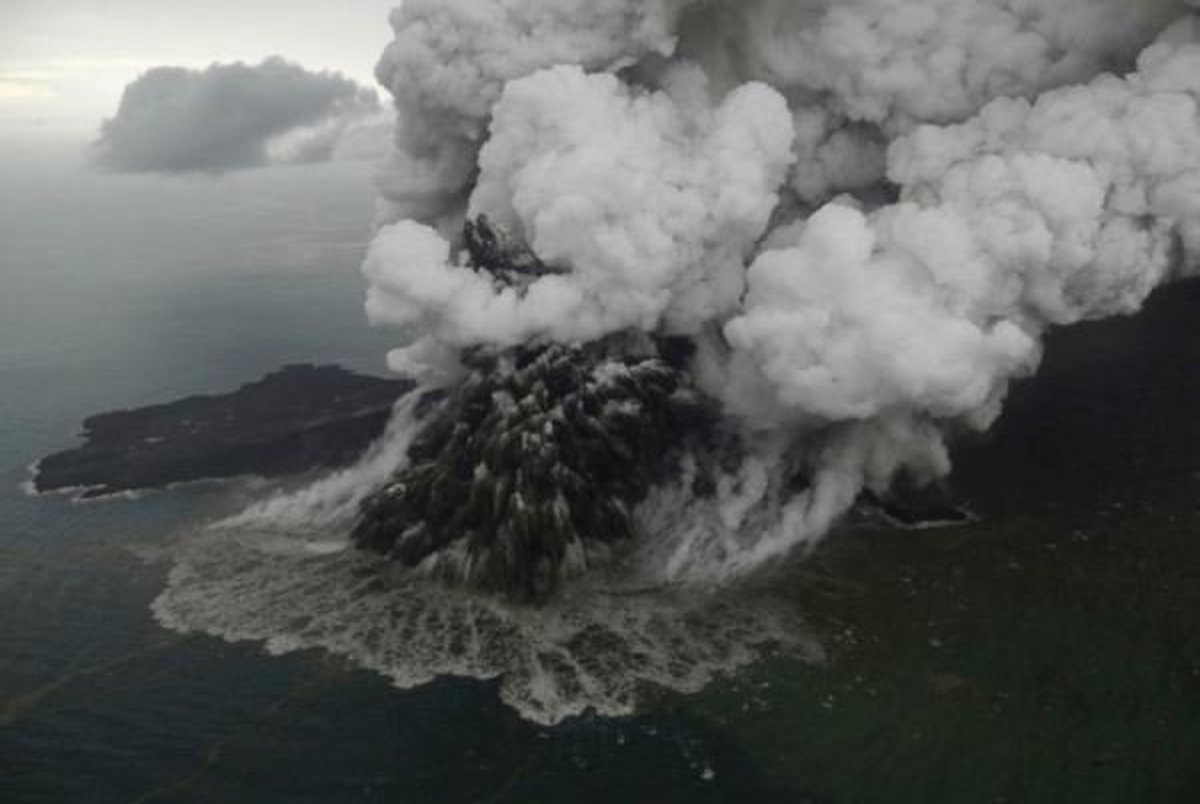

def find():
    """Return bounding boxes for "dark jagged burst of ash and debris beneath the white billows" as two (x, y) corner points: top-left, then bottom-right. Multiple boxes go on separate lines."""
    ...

(353, 337), (712, 601)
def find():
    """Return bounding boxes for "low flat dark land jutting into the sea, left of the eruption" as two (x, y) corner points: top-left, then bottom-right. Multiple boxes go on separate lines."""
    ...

(34, 365), (413, 497)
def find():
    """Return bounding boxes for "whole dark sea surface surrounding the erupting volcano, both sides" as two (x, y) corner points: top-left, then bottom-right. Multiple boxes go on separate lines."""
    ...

(0, 141), (1200, 803)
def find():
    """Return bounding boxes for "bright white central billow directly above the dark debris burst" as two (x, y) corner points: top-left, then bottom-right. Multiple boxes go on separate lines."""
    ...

(366, 67), (792, 374)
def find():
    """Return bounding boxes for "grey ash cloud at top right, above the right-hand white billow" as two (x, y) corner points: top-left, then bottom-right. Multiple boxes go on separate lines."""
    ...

(679, 0), (1184, 202)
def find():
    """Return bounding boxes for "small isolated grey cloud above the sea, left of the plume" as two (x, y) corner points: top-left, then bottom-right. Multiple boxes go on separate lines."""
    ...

(91, 56), (390, 173)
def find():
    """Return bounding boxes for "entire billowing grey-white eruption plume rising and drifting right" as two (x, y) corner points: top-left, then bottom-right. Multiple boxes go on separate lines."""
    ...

(365, 0), (1200, 585)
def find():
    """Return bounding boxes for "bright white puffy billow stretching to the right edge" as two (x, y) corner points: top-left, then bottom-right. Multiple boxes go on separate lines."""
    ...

(726, 15), (1200, 420)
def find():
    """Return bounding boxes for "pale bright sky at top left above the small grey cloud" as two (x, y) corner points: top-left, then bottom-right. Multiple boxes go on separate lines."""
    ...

(0, 0), (398, 136)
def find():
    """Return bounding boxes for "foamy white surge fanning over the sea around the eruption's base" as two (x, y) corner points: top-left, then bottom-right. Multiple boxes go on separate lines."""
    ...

(152, 400), (823, 725)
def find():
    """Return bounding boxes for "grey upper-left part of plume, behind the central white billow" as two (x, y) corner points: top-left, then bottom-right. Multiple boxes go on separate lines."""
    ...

(376, 0), (690, 226)
